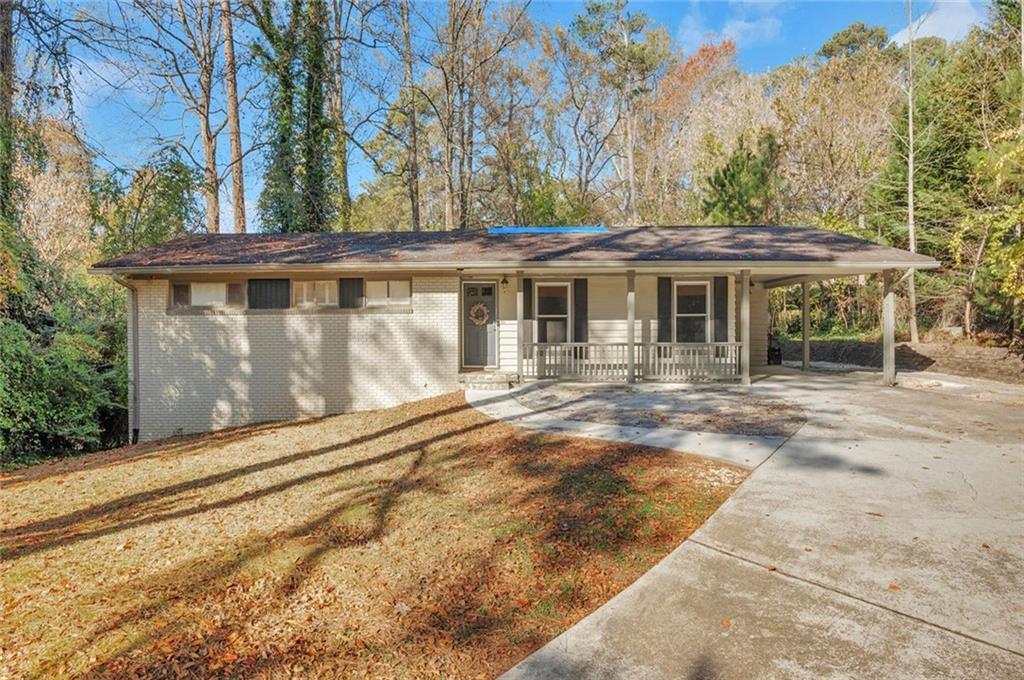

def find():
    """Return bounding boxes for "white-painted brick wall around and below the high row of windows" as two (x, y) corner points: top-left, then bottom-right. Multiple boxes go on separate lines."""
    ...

(129, 277), (459, 440)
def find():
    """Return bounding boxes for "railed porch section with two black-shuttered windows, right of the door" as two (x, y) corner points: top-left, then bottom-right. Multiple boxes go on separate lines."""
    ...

(502, 269), (768, 385)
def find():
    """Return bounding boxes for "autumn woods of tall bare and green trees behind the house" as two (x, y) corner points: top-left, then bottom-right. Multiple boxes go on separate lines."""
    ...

(0, 0), (1024, 465)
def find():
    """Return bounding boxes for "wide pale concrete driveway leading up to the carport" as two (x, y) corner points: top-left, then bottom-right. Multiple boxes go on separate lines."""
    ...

(479, 370), (1024, 678)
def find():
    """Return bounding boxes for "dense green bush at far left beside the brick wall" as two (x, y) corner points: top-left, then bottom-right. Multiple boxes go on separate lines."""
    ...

(0, 318), (123, 468)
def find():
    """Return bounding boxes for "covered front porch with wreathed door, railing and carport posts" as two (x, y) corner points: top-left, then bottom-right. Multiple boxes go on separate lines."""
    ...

(460, 269), (894, 386)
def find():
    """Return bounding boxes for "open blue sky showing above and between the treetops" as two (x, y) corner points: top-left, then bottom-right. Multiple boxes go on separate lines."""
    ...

(76, 0), (986, 230)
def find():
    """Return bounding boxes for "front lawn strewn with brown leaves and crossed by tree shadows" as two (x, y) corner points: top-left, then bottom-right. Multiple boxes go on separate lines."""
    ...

(0, 394), (745, 678)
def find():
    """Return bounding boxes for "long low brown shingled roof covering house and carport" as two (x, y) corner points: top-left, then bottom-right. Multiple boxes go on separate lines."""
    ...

(93, 226), (938, 274)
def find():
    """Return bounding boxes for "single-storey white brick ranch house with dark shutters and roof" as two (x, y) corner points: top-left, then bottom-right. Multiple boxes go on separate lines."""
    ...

(94, 227), (937, 440)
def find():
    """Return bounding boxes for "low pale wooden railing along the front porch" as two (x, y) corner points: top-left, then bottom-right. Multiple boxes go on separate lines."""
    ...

(522, 342), (741, 382)
